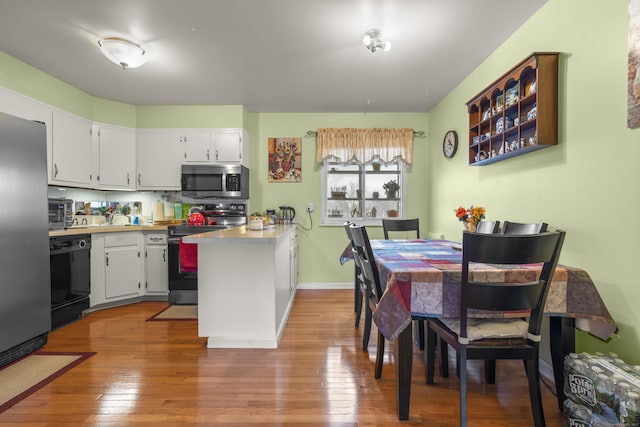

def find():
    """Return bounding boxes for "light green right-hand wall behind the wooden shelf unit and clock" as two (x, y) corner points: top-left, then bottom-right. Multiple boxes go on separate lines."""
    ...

(427, 0), (640, 363)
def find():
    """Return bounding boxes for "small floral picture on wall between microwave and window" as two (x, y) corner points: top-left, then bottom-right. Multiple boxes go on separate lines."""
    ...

(269, 138), (302, 182)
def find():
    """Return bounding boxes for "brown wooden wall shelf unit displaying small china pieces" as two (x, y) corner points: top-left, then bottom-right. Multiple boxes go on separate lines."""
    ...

(467, 53), (559, 166)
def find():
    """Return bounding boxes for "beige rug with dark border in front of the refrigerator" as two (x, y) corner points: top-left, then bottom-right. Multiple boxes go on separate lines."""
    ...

(0, 351), (95, 413)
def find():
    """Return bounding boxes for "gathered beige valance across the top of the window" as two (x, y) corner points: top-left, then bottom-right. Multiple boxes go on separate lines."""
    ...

(316, 128), (413, 164)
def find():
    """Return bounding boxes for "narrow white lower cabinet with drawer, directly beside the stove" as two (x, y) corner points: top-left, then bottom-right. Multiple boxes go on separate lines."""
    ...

(144, 233), (169, 295)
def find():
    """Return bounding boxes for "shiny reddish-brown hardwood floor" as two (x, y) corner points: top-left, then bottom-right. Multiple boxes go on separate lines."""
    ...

(0, 290), (562, 427)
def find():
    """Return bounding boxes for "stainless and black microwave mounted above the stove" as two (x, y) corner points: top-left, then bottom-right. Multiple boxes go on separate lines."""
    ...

(181, 165), (249, 199)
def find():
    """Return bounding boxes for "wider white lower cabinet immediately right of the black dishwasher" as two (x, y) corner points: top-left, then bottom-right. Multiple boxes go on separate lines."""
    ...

(91, 232), (145, 307)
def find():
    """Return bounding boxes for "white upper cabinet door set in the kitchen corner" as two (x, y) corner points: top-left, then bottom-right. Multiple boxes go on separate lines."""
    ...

(93, 124), (136, 190)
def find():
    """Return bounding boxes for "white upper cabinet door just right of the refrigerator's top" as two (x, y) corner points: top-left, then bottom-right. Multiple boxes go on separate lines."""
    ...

(49, 110), (92, 187)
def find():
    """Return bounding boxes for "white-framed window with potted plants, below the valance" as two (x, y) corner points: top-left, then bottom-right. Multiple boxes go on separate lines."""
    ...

(322, 158), (406, 225)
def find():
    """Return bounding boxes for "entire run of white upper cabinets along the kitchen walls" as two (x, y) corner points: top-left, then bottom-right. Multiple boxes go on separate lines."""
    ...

(0, 87), (249, 191)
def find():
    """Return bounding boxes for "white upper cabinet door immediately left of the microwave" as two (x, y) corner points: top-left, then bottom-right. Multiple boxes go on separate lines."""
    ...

(136, 131), (183, 190)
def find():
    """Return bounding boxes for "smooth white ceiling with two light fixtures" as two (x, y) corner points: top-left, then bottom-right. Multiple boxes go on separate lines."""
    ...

(0, 0), (546, 112)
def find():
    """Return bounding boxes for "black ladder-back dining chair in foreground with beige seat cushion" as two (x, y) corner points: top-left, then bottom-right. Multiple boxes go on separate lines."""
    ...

(425, 230), (565, 427)
